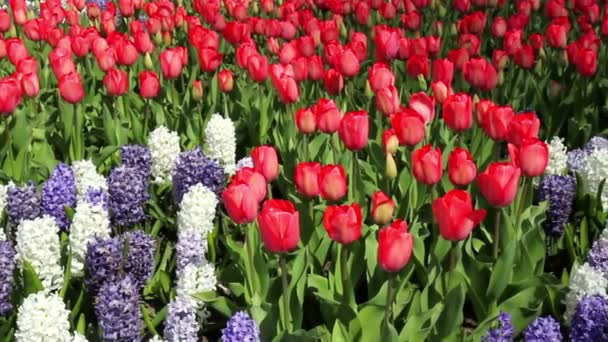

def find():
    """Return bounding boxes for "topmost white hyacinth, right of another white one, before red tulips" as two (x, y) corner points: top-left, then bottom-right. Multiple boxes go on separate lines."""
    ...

(205, 113), (236, 175)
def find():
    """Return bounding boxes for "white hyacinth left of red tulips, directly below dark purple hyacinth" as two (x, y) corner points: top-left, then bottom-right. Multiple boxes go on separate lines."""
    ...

(177, 183), (218, 239)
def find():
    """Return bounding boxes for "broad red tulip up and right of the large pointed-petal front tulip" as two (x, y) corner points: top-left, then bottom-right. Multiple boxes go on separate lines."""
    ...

(477, 162), (521, 207)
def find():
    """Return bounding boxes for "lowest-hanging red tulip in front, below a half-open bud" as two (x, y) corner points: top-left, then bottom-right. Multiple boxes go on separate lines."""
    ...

(378, 220), (414, 272)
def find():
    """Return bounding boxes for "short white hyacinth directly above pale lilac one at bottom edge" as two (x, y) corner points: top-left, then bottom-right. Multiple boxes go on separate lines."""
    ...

(176, 262), (217, 300)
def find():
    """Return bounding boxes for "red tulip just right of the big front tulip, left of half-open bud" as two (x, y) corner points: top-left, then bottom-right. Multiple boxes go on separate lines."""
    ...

(323, 203), (362, 245)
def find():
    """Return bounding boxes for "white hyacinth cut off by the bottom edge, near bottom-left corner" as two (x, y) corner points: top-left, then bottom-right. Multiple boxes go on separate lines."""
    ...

(15, 292), (72, 342)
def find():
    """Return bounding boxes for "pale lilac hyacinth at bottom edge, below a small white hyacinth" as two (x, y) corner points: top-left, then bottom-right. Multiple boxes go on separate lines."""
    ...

(164, 297), (199, 342)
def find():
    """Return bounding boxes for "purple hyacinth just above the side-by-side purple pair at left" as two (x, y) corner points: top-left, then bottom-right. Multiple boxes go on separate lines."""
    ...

(108, 166), (149, 226)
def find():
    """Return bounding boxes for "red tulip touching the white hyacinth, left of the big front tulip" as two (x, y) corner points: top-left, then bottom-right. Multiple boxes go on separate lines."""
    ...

(222, 184), (259, 224)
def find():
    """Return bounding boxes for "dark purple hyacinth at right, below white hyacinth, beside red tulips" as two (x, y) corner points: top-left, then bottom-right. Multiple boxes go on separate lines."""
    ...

(538, 175), (576, 237)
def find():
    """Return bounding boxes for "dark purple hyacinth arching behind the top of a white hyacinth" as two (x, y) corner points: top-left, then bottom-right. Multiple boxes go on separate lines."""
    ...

(173, 148), (225, 203)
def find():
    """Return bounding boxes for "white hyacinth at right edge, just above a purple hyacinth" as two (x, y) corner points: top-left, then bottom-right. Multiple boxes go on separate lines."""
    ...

(564, 263), (608, 322)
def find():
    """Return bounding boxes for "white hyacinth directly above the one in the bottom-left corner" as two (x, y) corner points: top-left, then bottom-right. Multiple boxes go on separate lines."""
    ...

(16, 215), (63, 290)
